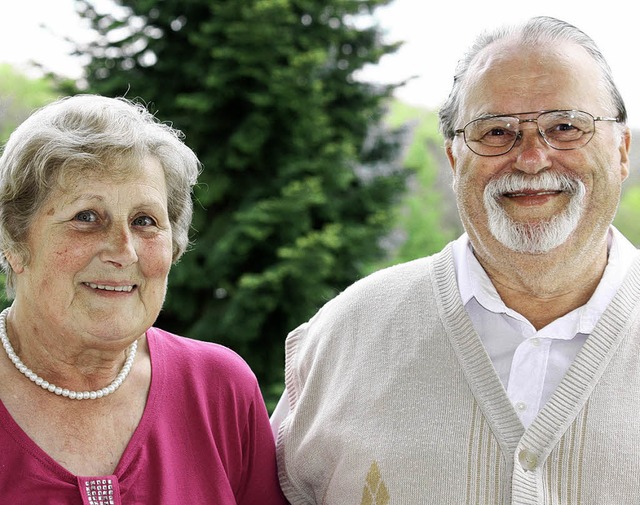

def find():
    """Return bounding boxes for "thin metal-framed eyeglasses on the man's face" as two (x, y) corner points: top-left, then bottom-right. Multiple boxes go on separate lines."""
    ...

(455, 110), (620, 156)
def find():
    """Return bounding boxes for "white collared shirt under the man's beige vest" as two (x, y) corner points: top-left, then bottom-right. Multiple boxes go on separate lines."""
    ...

(453, 227), (636, 427)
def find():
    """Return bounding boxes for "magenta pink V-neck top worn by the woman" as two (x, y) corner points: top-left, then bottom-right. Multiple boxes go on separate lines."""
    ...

(0, 328), (287, 505)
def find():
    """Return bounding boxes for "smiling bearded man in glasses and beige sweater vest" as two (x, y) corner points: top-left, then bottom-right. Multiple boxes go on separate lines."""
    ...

(273, 17), (640, 505)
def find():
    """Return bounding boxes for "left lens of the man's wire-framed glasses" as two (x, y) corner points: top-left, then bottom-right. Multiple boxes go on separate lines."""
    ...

(464, 116), (518, 156)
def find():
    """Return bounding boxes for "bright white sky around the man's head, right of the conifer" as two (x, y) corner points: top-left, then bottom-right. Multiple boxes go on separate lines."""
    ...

(370, 0), (640, 128)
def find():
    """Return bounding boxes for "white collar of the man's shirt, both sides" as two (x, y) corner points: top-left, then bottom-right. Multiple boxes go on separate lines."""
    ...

(453, 226), (637, 335)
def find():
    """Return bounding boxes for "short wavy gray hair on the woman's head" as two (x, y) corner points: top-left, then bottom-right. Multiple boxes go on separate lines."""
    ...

(0, 95), (200, 298)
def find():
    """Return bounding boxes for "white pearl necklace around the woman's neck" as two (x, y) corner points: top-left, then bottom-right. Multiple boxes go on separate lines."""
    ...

(0, 308), (138, 400)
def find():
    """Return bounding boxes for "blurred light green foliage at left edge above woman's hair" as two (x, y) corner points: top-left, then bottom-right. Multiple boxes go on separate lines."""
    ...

(0, 64), (56, 144)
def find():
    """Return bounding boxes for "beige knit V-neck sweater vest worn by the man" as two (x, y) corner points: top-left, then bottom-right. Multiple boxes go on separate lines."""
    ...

(277, 242), (640, 505)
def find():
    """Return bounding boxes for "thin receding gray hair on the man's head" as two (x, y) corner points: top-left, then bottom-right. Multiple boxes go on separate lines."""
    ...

(439, 16), (627, 140)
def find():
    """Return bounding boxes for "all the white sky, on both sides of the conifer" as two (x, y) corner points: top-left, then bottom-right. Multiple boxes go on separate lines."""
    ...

(0, 0), (640, 128)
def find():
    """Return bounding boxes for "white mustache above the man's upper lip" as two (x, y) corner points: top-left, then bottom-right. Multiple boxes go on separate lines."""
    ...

(484, 172), (585, 201)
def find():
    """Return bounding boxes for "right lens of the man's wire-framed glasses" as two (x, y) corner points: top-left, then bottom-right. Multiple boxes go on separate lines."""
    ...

(538, 110), (595, 149)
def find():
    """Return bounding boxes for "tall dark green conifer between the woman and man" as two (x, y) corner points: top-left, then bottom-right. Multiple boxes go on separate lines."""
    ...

(70, 0), (404, 406)
